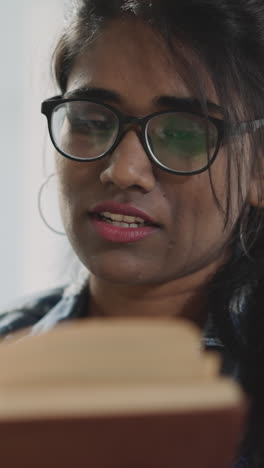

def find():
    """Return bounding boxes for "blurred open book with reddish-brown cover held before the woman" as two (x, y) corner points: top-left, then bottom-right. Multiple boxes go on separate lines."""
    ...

(0, 319), (247, 468)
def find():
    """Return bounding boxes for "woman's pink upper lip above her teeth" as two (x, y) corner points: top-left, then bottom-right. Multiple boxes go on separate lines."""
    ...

(90, 201), (159, 227)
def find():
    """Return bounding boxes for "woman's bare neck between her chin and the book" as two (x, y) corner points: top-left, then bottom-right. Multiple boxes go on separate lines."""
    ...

(89, 267), (221, 328)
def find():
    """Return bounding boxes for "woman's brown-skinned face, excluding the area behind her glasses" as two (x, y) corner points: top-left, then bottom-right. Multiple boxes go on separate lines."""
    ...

(57, 21), (242, 285)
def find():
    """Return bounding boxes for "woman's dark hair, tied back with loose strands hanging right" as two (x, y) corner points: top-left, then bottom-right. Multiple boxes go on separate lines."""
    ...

(53, 0), (264, 467)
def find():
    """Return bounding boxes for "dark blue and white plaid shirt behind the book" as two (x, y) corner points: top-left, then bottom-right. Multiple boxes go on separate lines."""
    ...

(0, 275), (252, 468)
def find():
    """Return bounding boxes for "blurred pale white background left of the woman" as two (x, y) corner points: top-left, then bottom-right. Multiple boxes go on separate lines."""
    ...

(0, 0), (74, 309)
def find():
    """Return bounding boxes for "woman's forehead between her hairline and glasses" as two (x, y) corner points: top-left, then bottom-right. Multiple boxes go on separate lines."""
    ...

(67, 19), (217, 112)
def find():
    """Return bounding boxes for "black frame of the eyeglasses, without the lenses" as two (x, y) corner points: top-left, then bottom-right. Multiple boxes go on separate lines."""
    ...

(41, 95), (264, 176)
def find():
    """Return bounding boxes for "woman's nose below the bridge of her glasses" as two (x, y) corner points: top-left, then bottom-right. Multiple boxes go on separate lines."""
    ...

(100, 130), (156, 193)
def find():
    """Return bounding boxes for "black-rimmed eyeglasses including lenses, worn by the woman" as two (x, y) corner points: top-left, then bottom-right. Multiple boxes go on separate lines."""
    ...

(41, 96), (264, 175)
